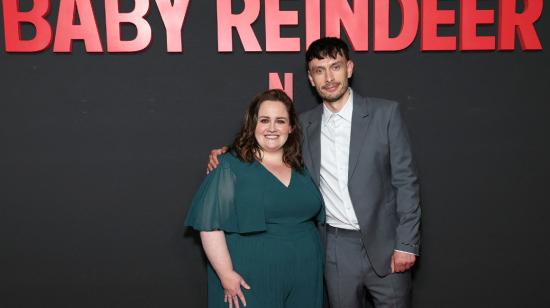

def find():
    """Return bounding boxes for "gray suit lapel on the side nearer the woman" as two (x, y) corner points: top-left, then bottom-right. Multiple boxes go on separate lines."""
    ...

(306, 105), (323, 186)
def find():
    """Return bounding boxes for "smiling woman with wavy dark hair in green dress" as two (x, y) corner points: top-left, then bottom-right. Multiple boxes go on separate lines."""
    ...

(185, 90), (324, 308)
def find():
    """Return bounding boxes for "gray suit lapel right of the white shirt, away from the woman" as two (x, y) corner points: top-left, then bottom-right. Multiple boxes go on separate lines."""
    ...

(348, 92), (369, 182)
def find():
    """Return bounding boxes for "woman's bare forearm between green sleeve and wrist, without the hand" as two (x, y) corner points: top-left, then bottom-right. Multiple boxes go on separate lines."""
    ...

(200, 231), (233, 278)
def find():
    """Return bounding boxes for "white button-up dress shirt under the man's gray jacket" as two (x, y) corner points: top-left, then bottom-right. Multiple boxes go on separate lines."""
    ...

(320, 89), (359, 230)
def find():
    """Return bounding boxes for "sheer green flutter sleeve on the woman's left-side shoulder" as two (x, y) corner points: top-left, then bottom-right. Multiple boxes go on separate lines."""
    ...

(184, 155), (239, 232)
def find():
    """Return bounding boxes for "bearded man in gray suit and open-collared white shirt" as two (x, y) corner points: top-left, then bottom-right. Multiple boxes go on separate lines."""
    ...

(209, 38), (420, 308)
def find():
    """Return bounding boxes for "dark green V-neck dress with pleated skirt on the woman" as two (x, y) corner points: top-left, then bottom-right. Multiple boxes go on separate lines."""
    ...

(185, 154), (325, 308)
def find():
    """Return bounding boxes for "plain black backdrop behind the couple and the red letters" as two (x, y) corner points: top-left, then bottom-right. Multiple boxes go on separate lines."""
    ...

(0, 0), (550, 307)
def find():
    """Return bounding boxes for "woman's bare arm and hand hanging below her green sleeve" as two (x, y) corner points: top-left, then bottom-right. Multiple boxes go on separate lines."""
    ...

(200, 231), (250, 308)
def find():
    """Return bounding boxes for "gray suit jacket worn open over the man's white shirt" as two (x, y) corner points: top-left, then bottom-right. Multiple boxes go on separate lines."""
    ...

(300, 91), (420, 276)
